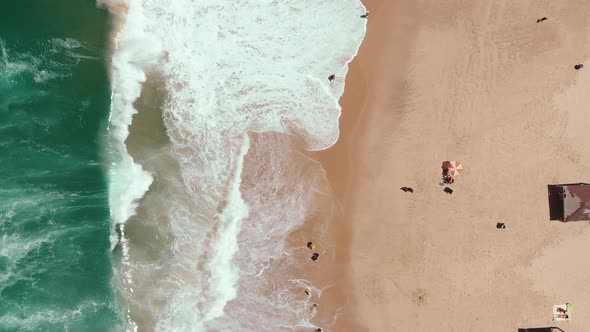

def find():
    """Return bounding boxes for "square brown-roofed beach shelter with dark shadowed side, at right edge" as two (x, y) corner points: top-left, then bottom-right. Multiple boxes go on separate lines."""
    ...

(547, 183), (590, 222)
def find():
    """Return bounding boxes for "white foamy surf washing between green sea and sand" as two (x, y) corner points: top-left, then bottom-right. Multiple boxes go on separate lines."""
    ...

(109, 0), (366, 331)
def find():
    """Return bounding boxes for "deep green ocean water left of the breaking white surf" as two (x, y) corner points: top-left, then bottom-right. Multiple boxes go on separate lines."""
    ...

(0, 0), (121, 331)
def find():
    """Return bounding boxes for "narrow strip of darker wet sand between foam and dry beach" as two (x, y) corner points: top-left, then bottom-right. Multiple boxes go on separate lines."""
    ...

(312, 0), (418, 331)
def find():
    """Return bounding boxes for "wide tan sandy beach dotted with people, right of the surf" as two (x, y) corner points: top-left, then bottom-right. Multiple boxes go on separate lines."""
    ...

(317, 0), (590, 332)
